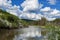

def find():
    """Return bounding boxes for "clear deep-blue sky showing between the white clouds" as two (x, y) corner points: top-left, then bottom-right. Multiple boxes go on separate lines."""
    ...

(12, 0), (60, 10)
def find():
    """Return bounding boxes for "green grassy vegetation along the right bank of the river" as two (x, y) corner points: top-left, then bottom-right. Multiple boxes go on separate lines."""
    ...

(45, 23), (60, 40)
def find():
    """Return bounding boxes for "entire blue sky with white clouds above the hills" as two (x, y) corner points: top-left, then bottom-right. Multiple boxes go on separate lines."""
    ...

(0, 0), (60, 21)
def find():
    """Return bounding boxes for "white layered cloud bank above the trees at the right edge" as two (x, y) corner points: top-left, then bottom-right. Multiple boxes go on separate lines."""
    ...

(40, 7), (60, 21)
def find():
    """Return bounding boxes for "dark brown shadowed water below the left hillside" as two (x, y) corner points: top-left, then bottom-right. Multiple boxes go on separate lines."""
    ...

(0, 29), (17, 40)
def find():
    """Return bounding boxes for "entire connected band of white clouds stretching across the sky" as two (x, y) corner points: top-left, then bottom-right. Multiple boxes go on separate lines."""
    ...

(0, 0), (60, 21)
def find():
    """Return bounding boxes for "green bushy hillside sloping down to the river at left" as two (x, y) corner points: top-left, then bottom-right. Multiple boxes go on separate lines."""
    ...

(0, 9), (20, 28)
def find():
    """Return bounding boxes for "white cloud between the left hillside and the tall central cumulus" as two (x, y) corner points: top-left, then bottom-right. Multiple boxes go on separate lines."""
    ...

(6, 5), (21, 16)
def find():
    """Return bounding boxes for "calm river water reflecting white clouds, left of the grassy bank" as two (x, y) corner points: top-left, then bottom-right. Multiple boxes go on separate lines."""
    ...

(0, 26), (48, 40)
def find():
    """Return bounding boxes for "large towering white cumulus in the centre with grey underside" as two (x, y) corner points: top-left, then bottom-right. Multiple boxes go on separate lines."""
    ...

(20, 0), (43, 20)
